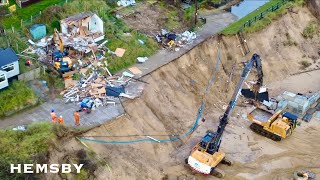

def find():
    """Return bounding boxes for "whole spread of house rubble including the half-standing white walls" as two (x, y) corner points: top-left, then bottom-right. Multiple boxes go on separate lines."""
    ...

(23, 13), (148, 109)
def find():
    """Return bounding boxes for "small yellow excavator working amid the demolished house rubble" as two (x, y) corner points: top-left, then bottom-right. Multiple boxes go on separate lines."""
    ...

(52, 28), (72, 74)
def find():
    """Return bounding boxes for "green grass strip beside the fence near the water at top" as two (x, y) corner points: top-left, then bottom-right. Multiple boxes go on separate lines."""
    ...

(222, 0), (281, 35)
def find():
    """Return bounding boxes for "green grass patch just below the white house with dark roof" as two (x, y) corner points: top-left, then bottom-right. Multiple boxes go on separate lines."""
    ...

(0, 81), (38, 117)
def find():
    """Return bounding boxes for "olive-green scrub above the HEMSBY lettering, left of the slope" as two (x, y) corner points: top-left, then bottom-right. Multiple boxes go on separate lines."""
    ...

(0, 122), (57, 179)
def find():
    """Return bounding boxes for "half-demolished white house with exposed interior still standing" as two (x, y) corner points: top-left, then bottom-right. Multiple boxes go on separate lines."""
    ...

(60, 12), (104, 42)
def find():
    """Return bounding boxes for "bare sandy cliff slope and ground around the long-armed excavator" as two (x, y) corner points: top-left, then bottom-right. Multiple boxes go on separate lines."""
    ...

(43, 7), (320, 179)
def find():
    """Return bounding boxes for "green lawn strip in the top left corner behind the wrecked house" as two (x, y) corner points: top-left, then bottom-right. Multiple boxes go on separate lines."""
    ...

(2, 0), (65, 29)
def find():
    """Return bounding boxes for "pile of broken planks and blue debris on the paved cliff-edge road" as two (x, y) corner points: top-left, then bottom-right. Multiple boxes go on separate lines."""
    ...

(62, 70), (144, 112)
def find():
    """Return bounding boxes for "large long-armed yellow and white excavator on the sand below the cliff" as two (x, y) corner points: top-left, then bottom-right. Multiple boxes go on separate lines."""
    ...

(186, 54), (263, 178)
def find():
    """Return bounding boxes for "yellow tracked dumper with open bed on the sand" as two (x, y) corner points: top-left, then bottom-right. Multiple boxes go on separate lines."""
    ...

(247, 108), (299, 141)
